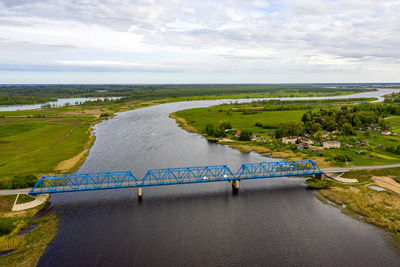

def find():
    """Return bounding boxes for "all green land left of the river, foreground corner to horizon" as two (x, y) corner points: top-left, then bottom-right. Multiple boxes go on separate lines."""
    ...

(0, 85), (376, 266)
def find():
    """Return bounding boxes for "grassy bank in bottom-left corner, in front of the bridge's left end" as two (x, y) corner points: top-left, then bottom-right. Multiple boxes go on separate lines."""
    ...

(0, 195), (59, 266)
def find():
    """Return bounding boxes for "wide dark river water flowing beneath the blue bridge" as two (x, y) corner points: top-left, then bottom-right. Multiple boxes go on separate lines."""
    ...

(39, 91), (400, 266)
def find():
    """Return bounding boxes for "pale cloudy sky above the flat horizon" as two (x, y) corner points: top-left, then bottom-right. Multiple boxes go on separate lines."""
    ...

(0, 0), (400, 83)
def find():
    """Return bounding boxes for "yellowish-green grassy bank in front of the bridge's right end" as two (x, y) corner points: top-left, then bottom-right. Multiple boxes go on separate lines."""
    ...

(307, 168), (400, 238)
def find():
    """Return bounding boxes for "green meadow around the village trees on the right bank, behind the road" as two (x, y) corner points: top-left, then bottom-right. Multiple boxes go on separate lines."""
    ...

(171, 101), (400, 167)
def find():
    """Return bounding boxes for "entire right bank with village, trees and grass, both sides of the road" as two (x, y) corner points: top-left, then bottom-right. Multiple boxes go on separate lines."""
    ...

(171, 94), (400, 244)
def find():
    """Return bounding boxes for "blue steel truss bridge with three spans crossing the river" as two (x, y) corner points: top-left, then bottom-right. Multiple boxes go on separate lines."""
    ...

(29, 160), (323, 197)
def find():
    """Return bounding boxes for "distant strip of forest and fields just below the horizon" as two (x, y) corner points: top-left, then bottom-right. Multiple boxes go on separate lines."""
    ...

(0, 84), (376, 105)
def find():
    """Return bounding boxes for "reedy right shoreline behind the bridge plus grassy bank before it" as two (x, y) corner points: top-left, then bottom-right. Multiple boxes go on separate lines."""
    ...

(170, 109), (400, 247)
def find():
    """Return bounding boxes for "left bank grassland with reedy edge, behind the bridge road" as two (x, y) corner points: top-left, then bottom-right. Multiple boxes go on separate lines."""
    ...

(0, 98), (165, 188)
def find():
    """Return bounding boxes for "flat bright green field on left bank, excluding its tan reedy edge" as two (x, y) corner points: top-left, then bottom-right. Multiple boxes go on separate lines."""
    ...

(0, 116), (92, 176)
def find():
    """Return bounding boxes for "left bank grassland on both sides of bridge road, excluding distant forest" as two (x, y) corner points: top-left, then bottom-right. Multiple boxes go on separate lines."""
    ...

(0, 95), (169, 266)
